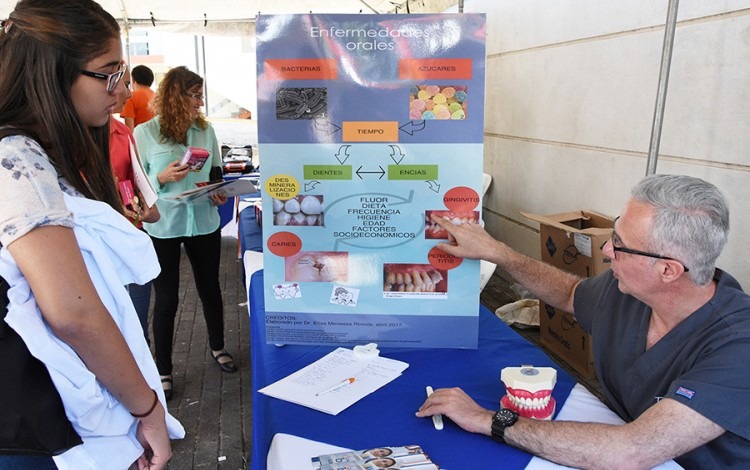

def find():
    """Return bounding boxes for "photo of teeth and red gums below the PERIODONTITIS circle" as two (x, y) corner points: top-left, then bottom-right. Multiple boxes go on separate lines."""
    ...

(383, 263), (448, 298)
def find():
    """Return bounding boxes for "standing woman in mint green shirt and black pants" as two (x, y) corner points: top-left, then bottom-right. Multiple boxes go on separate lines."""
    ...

(134, 67), (237, 399)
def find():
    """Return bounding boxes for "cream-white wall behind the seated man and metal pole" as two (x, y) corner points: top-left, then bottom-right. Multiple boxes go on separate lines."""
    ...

(453, 0), (750, 288)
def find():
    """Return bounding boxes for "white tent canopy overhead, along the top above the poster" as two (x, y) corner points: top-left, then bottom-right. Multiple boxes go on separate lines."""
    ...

(0, 0), (459, 35)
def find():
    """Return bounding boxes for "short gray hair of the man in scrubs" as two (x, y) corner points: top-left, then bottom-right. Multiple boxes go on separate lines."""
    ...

(631, 175), (729, 286)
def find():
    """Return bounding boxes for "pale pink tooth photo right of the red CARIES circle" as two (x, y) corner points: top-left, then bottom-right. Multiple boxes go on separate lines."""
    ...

(284, 251), (349, 282)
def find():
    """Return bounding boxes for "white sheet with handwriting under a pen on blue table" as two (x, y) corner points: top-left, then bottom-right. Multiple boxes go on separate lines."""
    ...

(258, 348), (409, 415)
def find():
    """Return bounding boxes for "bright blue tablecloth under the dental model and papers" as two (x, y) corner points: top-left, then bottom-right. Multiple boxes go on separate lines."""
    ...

(249, 271), (575, 470)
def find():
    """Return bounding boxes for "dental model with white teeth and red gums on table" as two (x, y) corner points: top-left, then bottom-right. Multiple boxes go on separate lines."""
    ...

(500, 366), (557, 420)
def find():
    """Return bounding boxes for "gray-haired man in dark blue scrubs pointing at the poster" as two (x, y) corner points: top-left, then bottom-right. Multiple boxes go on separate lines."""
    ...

(417, 175), (750, 469)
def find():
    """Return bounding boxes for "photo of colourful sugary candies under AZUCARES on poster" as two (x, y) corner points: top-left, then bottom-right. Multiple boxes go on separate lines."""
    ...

(409, 85), (468, 121)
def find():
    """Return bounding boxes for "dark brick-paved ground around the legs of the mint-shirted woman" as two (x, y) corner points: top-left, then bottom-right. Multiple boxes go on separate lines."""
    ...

(151, 237), (252, 470)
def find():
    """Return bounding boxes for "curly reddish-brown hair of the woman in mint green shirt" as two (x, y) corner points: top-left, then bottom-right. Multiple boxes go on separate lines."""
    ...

(154, 66), (208, 145)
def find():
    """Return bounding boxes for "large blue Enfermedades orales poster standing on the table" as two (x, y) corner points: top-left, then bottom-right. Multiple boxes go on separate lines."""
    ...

(256, 14), (486, 348)
